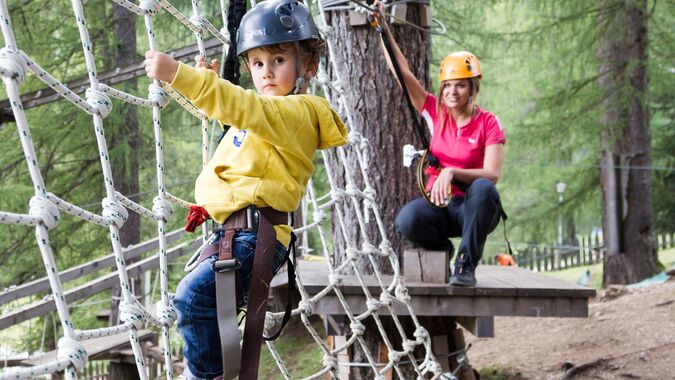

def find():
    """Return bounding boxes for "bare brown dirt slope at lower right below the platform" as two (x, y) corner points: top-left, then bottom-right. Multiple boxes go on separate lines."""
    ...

(466, 279), (675, 380)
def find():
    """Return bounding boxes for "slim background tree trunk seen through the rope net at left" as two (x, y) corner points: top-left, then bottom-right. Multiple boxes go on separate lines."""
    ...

(104, 5), (143, 325)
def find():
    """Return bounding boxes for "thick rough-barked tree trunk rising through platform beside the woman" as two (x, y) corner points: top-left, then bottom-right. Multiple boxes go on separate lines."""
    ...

(327, 5), (429, 379)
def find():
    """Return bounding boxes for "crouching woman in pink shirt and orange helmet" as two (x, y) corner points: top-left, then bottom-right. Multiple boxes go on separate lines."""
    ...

(376, 4), (506, 286)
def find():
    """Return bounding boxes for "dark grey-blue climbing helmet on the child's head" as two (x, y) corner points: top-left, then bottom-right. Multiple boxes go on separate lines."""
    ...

(237, 0), (321, 56)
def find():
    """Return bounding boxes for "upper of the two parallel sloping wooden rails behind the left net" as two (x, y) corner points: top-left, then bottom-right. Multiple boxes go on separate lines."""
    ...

(0, 228), (184, 306)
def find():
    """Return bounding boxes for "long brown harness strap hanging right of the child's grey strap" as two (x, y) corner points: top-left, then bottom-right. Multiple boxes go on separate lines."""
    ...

(239, 208), (287, 380)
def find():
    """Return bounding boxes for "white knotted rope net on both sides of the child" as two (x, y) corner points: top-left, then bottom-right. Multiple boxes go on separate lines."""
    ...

(0, 0), (454, 380)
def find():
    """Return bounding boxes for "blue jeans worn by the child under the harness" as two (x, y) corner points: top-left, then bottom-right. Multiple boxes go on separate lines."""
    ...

(173, 230), (286, 380)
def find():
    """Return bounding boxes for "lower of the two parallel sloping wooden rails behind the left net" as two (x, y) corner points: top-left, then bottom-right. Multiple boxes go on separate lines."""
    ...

(0, 238), (202, 330)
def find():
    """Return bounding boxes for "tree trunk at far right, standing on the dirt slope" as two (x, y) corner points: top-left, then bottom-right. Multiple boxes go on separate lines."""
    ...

(598, 0), (658, 286)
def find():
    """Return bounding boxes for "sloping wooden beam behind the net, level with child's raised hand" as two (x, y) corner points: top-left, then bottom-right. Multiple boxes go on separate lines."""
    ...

(0, 38), (223, 122)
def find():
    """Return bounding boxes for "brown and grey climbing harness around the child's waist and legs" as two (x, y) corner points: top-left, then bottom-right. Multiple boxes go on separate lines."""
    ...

(190, 206), (296, 379)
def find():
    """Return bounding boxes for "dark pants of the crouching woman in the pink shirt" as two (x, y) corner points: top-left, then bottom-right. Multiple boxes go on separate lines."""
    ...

(395, 178), (503, 267)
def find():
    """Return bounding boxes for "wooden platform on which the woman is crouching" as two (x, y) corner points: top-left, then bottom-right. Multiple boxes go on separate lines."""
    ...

(272, 261), (596, 337)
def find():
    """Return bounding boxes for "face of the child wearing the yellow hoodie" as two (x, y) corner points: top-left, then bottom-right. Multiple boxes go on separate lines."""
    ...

(246, 45), (306, 96)
